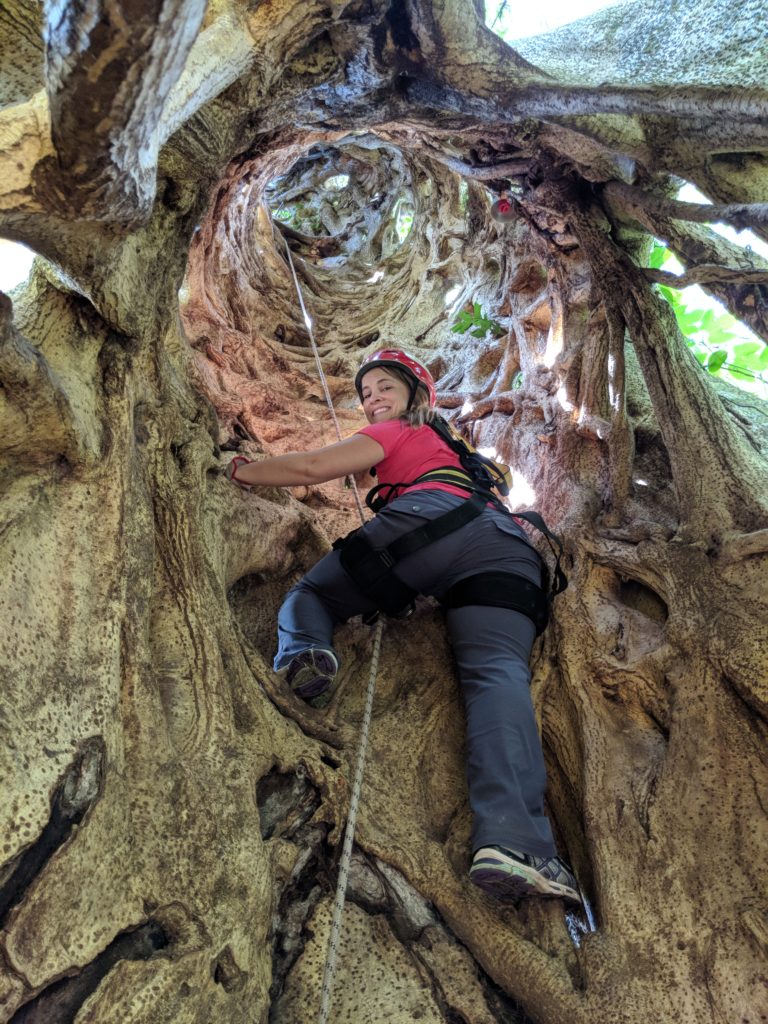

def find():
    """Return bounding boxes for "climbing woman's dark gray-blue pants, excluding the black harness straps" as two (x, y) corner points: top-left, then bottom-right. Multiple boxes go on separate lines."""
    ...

(274, 490), (556, 857)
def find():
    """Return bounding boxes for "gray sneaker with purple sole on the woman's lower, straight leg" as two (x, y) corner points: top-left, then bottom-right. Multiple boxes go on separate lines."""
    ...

(469, 846), (582, 903)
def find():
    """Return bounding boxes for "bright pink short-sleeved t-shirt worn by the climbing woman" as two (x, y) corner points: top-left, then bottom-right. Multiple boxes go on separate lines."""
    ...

(357, 420), (468, 502)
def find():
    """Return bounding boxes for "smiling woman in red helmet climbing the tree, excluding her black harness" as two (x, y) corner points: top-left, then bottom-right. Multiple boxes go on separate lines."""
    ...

(226, 349), (581, 902)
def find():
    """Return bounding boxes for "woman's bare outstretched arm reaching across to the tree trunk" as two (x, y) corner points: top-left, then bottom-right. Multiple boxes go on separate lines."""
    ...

(227, 434), (384, 487)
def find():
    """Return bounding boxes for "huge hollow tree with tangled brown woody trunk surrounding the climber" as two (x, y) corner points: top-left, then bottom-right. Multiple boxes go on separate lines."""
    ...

(0, 0), (768, 1024)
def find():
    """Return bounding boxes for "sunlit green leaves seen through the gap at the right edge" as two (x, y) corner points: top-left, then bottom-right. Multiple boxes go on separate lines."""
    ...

(650, 243), (768, 392)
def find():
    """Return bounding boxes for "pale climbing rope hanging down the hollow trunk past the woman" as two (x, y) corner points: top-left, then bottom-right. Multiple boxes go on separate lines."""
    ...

(272, 224), (384, 1024)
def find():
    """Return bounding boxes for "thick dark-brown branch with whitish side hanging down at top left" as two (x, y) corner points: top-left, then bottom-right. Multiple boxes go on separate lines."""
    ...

(37, 0), (205, 221)
